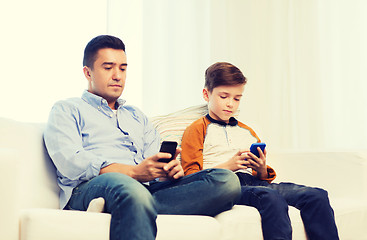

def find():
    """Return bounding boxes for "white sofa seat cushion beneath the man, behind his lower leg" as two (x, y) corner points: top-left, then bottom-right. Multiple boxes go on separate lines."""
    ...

(20, 208), (221, 240)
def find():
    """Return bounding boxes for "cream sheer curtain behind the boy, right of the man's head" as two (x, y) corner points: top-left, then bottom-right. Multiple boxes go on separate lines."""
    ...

(109, 0), (367, 150)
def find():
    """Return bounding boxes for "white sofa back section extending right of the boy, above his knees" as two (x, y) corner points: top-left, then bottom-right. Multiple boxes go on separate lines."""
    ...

(267, 151), (367, 199)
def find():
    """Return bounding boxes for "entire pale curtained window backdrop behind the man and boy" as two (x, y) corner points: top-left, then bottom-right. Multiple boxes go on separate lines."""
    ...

(0, 0), (367, 149)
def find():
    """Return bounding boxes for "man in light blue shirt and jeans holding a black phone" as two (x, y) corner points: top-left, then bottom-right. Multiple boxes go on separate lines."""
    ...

(44, 35), (240, 240)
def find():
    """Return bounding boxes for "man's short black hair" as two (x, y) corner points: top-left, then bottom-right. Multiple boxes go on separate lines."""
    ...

(83, 35), (125, 69)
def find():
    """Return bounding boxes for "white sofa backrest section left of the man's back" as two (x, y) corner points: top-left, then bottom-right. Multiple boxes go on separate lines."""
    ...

(0, 118), (60, 208)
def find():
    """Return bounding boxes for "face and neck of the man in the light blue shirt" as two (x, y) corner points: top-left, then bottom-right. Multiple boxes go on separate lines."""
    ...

(83, 48), (127, 109)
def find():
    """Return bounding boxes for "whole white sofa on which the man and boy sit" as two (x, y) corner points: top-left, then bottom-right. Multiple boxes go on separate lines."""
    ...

(0, 105), (367, 240)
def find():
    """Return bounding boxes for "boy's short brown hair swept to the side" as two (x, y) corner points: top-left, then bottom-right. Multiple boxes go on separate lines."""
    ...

(204, 62), (247, 92)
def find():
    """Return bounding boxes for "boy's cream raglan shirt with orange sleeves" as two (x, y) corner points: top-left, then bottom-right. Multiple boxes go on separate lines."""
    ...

(181, 115), (276, 182)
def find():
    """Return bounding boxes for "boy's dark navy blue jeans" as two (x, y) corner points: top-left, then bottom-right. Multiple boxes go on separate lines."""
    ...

(236, 172), (339, 240)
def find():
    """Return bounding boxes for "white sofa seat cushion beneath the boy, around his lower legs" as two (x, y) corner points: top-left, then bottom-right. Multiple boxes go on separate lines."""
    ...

(215, 198), (367, 240)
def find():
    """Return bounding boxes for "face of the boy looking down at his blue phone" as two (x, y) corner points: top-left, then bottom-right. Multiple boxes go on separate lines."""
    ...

(203, 84), (245, 123)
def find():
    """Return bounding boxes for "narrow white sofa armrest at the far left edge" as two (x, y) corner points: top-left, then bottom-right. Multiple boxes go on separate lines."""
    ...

(0, 148), (19, 240)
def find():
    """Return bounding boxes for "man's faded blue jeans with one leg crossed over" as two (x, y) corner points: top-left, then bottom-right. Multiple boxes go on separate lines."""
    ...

(65, 169), (241, 240)
